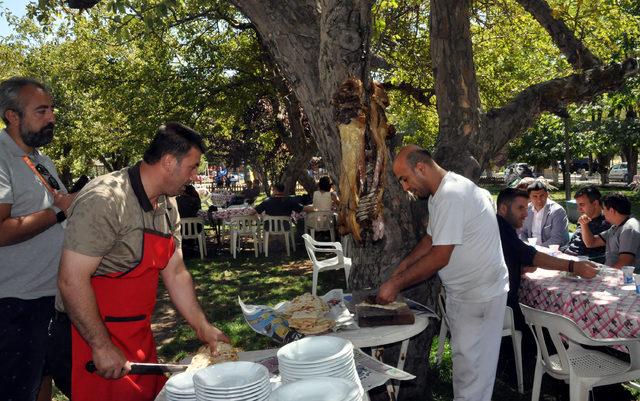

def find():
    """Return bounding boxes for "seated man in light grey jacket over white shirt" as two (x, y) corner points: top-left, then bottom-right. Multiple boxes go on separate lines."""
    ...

(520, 180), (569, 247)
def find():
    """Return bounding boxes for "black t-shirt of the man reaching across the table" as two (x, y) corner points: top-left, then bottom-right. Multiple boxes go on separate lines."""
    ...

(496, 215), (538, 313)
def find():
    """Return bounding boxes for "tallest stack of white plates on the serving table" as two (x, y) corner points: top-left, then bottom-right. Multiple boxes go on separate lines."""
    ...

(278, 336), (360, 386)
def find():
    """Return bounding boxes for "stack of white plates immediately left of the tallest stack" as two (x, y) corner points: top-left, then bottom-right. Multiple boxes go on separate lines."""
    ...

(193, 362), (271, 401)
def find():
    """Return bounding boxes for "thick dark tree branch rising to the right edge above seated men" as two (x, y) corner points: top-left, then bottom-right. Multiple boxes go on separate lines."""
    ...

(475, 58), (639, 164)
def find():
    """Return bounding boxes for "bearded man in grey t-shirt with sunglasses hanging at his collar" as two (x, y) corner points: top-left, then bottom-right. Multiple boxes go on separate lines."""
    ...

(0, 77), (73, 401)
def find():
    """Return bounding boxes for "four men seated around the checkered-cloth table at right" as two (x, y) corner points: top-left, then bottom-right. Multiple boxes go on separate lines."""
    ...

(497, 180), (640, 332)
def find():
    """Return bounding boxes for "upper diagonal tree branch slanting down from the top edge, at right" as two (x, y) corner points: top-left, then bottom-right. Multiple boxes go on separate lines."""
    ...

(517, 0), (600, 70)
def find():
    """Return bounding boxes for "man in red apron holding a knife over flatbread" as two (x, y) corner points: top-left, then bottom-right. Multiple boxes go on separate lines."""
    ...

(53, 123), (228, 401)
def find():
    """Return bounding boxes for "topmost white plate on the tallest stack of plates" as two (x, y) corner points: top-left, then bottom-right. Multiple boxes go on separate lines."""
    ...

(278, 336), (353, 365)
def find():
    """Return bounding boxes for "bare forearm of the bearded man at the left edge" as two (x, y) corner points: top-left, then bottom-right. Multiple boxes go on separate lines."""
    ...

(0, 209), (58, 246)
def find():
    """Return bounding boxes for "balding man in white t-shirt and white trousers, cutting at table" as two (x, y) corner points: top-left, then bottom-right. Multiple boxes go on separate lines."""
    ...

(377, 145), (509, 401)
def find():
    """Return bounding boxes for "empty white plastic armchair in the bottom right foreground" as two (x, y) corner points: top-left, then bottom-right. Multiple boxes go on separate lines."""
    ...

(520, 304), (640, 401)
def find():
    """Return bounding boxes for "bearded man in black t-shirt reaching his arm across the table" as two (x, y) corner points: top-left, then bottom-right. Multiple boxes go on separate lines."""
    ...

(497, 188), (596, 330)
